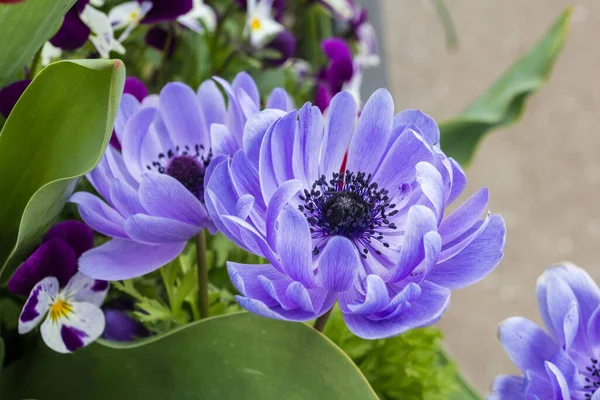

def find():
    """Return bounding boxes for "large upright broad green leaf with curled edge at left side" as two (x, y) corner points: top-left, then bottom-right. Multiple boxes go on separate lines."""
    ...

(0, 60), (125, 283)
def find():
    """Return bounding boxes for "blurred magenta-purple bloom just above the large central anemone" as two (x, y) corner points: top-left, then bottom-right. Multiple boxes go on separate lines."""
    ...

(315, 37), (354, 111)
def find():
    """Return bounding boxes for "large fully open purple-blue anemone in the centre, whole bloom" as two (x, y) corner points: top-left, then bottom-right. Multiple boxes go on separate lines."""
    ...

(205, 89), (505, 339)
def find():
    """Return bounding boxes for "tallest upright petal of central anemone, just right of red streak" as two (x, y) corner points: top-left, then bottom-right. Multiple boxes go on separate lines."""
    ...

(348, 89), (394, 176)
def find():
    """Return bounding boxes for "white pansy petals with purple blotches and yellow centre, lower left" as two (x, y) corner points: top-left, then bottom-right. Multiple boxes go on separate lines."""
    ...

(19, 272), (108, 353)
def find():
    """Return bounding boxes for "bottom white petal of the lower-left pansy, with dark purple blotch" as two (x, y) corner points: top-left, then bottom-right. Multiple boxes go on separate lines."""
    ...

(41, 302), (105, 353)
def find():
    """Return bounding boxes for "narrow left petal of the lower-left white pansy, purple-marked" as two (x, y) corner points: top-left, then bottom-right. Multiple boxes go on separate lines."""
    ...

(19, 276), (59, 335)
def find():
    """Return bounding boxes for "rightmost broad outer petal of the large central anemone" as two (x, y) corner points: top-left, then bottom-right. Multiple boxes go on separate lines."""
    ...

(427, 215), (506, 289)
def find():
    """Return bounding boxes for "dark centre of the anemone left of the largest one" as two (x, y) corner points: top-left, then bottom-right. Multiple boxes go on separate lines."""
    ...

(146, 145), (212, 203)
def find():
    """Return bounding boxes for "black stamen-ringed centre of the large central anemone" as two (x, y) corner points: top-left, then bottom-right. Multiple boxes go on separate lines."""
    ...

(299, 171), (398, 258)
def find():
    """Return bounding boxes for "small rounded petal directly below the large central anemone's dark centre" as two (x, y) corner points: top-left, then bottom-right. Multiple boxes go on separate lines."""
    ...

(317, 236), (361, 292)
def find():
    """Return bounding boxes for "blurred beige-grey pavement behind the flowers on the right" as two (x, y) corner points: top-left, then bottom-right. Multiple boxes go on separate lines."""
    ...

(363, 0), (600, 390)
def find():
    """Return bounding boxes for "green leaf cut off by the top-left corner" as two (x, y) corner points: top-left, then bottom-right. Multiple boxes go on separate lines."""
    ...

(0, 0), (76, 88)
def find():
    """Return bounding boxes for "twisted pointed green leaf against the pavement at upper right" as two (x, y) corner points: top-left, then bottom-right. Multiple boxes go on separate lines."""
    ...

(440, 9), (571, 166)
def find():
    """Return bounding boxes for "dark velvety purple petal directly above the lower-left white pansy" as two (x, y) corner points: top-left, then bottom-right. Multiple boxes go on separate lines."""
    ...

(8, 239), (77, 296)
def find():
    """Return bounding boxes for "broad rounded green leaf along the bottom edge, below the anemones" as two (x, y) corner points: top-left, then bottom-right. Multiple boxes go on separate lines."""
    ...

(0, 313), (377, 400)
